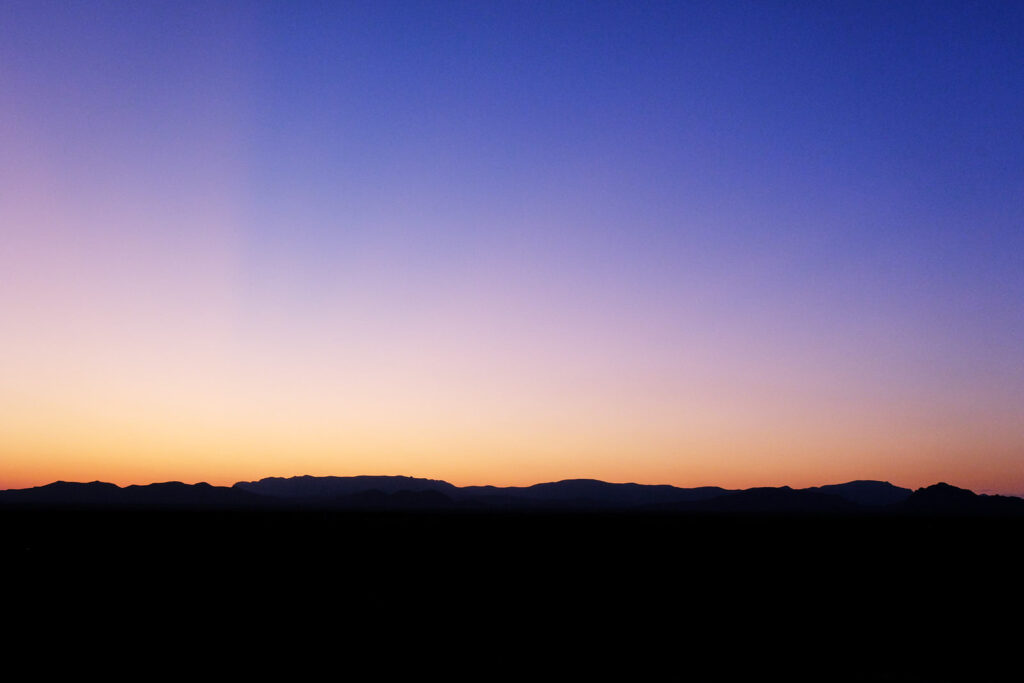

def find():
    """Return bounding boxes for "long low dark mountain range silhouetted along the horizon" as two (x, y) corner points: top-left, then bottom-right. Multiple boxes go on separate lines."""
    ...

(0, 476), (1024, 516)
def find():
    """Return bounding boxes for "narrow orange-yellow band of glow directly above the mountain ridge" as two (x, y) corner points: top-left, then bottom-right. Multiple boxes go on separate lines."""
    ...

(0, 378), (1017, 493)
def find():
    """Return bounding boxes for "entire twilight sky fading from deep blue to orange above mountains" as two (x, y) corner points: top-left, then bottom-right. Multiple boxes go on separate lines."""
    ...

(0, 0), (1024, 495)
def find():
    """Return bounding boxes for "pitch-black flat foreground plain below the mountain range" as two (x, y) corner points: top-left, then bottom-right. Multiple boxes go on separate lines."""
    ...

(0, 507), (1024, 681)
